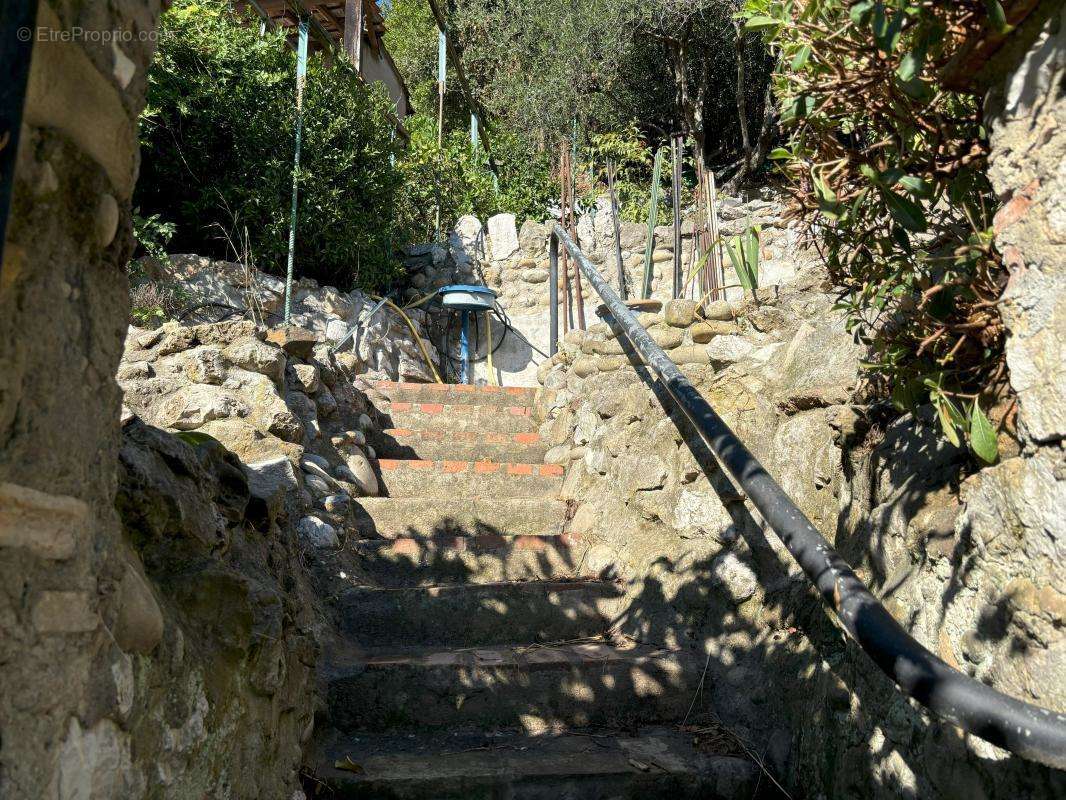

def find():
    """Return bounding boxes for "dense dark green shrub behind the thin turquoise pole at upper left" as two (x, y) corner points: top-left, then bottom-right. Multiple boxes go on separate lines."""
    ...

(135, 0), (404, 288)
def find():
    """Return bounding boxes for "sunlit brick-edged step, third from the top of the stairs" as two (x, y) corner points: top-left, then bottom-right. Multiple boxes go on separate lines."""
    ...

(370, 428), (548, 463)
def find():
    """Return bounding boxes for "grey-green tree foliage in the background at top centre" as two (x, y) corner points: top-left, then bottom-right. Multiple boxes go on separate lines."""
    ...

(388, 0), (770, 204)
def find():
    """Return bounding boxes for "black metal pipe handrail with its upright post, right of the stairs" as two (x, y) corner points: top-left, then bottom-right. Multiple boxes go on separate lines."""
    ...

(549, 224), (1066, 769)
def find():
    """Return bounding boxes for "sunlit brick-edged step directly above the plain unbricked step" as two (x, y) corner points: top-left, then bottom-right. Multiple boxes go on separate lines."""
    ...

(377, 459), (563, 502)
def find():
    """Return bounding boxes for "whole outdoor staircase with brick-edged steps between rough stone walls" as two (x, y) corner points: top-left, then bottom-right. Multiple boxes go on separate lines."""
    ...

(309, 382), (757, 800)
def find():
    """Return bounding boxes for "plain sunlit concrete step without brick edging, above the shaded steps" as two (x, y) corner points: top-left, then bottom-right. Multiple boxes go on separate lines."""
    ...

(355, 497), (566, 539)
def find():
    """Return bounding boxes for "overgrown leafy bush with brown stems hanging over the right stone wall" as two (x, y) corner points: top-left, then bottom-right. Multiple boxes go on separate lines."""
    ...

(744, 0), (1006, 461)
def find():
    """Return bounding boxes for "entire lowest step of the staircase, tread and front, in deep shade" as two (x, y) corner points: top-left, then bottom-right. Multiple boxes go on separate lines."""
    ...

(311, 727), (770, 800)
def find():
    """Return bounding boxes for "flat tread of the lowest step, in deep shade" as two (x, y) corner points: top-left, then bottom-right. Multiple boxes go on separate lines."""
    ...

(314, 725), (754, 784)
